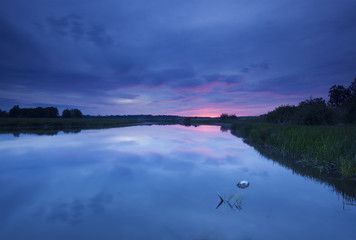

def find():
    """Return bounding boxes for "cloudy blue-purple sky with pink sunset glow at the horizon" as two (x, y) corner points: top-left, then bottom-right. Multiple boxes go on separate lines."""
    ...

(0, 0), (356, 116)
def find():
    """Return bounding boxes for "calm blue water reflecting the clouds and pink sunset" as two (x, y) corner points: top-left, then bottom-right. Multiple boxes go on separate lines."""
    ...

(0, 126), (356, 240)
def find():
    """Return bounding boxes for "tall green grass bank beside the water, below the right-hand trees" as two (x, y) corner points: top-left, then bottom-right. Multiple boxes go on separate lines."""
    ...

(231, 122), (356, 180)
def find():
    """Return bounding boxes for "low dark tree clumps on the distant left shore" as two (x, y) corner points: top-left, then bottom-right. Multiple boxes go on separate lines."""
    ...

(0, 105), (83, 118)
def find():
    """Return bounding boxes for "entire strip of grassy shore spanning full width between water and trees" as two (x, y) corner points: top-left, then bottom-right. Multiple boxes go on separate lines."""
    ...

(0, 117), (356, 181)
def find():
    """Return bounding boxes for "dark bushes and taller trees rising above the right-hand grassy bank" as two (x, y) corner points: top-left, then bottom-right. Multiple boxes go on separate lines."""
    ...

(261, 78), (356, 125)
